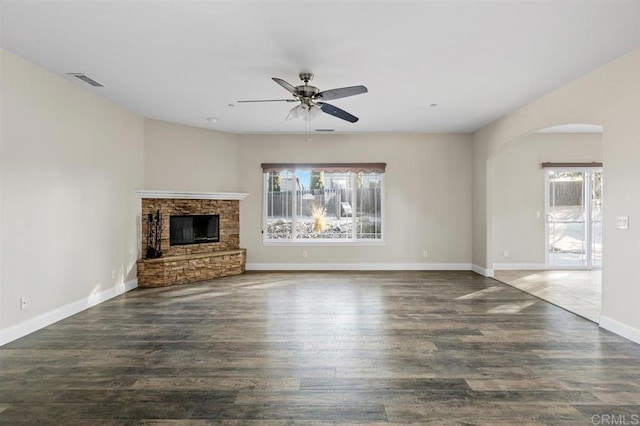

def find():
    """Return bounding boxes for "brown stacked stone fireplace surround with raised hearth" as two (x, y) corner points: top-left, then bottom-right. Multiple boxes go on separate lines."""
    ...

(137, 198), (246, 287)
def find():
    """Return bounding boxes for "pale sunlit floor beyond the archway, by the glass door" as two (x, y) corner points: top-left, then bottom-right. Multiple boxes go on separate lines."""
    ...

(494, 270), (602, 323)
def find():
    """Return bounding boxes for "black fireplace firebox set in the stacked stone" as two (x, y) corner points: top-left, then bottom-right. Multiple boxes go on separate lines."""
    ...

(169, 214), (220, 246)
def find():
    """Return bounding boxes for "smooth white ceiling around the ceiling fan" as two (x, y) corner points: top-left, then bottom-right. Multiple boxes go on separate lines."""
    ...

(1, 0), (640, 133)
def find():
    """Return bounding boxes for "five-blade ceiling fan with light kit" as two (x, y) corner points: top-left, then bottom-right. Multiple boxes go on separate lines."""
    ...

(238, 72), (368, 123)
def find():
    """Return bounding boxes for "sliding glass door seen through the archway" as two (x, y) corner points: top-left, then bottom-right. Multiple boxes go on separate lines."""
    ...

(545, 169), (602, 268)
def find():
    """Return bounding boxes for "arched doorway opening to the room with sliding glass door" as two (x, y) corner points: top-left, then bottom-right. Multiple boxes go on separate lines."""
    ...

(488, 124), (603, 322)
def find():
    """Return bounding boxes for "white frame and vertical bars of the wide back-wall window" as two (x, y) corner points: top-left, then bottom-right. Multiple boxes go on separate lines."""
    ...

(262, 170), (386, 247)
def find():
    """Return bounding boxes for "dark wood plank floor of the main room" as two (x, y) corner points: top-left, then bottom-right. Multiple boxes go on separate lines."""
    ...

(0, 272), (640, 425)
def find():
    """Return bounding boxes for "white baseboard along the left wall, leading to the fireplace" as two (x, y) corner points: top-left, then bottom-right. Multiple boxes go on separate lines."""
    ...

(0, 279), (138, 346)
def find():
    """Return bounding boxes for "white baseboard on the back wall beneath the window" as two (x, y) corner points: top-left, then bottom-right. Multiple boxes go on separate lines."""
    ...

(246, 263), (471, 271)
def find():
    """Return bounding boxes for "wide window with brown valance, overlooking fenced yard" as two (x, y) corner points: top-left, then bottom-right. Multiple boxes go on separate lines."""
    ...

(262, 163), (385, 243)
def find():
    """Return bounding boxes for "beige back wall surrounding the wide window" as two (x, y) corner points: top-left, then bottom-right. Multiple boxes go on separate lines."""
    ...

(240, 134), (471, 265)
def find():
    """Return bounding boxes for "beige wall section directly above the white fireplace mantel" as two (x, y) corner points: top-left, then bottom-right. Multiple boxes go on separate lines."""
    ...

(144, 120), (240, 192)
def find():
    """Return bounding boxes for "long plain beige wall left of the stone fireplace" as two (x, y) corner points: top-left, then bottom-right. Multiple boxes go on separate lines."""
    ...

(0, 50), (144, 337)
